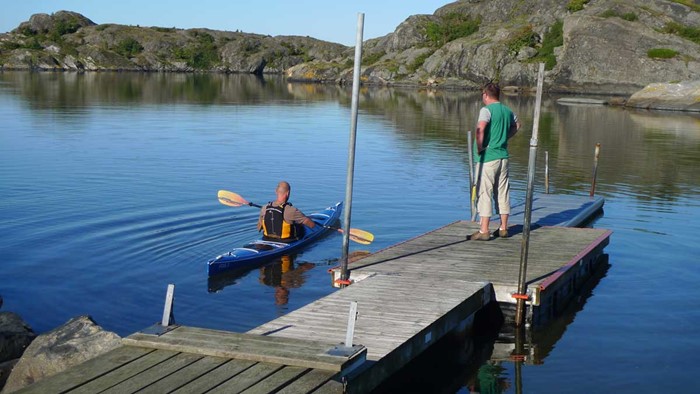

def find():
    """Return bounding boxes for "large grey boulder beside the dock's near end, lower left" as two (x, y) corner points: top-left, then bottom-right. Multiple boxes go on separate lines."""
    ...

(3, 316), (121, 393)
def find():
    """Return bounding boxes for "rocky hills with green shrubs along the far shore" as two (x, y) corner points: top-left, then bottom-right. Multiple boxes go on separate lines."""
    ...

(0, 0), (700, 98)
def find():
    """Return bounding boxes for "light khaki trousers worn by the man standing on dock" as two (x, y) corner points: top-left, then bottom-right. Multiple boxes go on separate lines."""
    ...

(474, 159), (510, 218)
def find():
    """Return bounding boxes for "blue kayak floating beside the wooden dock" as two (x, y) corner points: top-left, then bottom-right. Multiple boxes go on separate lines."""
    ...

(207, 202), (343, 276)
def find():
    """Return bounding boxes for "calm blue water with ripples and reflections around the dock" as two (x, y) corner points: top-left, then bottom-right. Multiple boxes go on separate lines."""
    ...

(0, 72), (700, 393)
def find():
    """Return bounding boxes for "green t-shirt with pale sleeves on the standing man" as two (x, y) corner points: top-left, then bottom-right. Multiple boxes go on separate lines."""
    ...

(474, 102), (517, 163)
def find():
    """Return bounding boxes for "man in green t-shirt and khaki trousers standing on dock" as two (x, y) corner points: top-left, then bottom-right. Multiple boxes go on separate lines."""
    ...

(468, 82), (520, 241)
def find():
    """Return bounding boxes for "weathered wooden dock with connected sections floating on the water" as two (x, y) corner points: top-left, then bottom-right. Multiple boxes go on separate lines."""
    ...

(15, 195), (610, 393)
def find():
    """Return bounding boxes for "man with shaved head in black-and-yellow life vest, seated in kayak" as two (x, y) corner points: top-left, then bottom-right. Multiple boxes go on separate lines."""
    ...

(258, 181), (316, 242)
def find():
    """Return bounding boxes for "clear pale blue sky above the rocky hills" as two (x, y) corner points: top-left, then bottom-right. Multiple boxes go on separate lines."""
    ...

(0, 0), (452, 46)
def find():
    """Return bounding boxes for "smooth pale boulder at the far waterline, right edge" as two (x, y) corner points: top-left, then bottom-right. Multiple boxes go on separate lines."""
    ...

(626, 80), (700, 112)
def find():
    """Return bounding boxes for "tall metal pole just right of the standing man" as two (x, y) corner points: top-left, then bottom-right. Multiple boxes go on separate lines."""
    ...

(515, 63), (544, 326)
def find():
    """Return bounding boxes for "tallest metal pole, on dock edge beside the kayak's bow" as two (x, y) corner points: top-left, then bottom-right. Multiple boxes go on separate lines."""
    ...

(340, 13), (365, 281)
